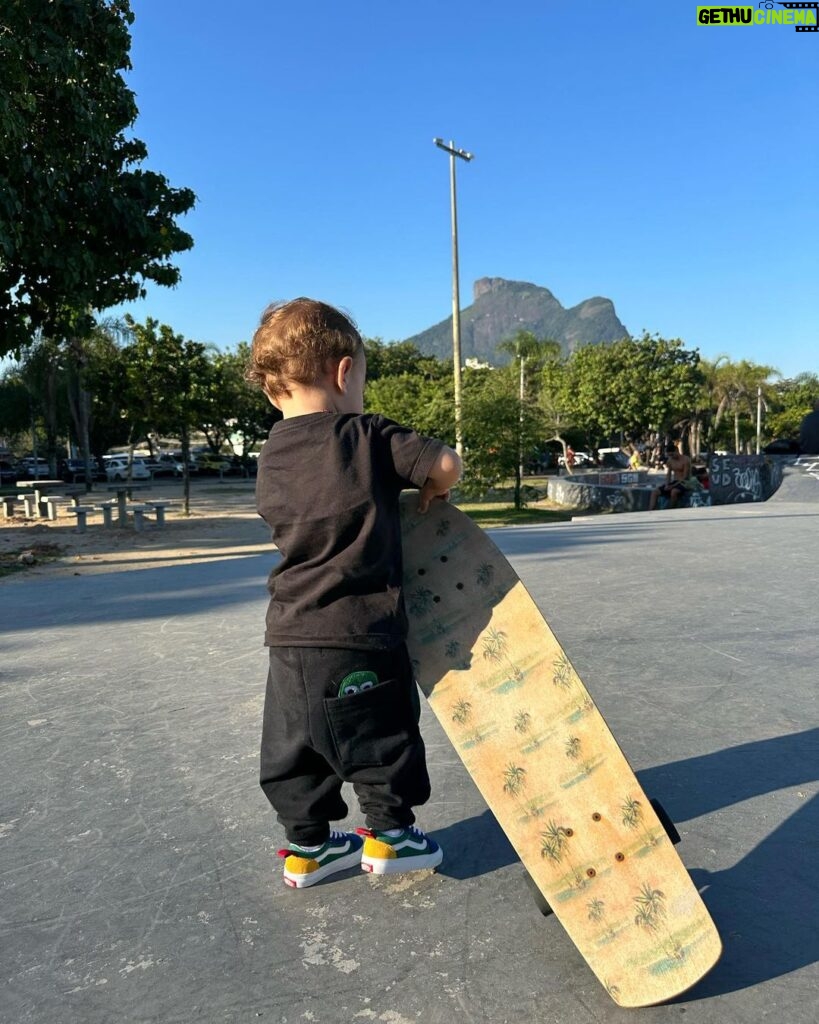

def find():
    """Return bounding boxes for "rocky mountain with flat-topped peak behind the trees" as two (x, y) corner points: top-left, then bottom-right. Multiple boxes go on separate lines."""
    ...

(406, 278), (629, 366)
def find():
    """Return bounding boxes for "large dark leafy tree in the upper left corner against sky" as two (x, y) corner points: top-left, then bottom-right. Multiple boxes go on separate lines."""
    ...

(0, 0), (196, 354)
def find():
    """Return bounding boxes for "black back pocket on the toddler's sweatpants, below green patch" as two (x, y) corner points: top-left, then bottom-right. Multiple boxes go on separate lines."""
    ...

(325, 679), (418, 768)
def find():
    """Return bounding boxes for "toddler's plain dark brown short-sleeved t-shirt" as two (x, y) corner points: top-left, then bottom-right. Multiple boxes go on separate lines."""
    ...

(256, 413), (442, 649)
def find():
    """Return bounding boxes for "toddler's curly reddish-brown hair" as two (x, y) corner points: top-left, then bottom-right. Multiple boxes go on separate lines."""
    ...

(245, 297), (363, 398)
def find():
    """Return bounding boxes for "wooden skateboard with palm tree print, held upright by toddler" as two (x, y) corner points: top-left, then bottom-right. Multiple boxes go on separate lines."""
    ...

(401, 493), (722, 1007)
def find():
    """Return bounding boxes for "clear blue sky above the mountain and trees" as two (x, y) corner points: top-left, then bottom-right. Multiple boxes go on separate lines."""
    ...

(116, 0), (819, 376)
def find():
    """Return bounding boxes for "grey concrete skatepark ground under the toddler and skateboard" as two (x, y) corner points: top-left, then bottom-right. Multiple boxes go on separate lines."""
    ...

(0, 473), (819, 1024)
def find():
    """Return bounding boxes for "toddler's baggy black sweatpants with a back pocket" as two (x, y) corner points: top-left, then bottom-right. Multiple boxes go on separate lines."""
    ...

(260, 645), (430, 846)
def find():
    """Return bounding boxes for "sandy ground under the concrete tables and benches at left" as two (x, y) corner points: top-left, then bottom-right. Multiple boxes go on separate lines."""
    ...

(0, 480), (273, 585)
